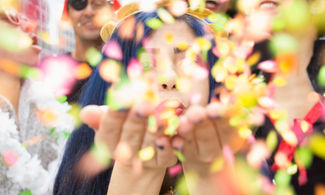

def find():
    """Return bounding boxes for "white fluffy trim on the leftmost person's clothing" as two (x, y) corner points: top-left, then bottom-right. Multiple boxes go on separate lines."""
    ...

(0, 80), (74, 195)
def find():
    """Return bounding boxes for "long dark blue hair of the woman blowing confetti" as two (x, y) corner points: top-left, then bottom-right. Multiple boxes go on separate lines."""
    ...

(54, 12), (217, 195)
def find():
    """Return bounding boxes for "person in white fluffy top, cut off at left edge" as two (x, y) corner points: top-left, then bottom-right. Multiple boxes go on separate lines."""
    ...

(0, 7), (73, 195)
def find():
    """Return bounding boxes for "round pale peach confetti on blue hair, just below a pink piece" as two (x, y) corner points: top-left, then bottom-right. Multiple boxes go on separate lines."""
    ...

(99, 59), (122, 83)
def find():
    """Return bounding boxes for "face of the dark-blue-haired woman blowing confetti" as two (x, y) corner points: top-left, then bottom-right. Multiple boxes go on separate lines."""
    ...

(145, 20), (209, 108)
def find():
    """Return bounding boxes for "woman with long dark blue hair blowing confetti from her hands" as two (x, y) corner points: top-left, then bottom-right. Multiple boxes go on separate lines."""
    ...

(54, 1), (246, 194)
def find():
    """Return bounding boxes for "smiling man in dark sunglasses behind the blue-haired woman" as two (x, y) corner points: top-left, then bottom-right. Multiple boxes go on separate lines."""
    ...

(62, 0), (120, 103)
